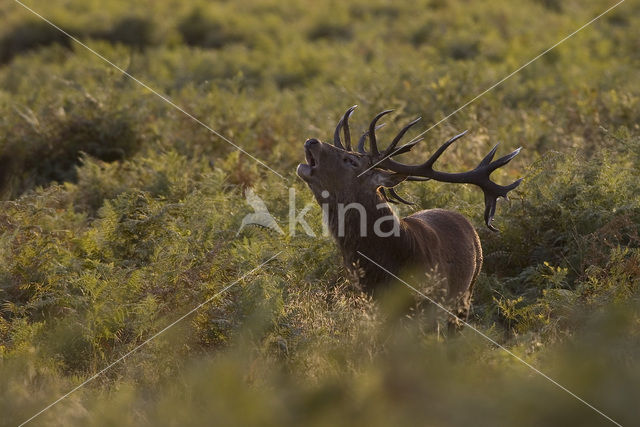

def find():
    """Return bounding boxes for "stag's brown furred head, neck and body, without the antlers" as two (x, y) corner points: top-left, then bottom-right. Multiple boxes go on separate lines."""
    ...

(298, 141), (482, 320)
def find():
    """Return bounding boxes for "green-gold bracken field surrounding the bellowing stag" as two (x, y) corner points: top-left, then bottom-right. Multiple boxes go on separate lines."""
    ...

(0, 0), (640, 426)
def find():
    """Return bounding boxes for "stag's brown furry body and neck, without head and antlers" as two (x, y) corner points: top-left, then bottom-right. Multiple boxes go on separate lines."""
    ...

(329, 188), (482, 320)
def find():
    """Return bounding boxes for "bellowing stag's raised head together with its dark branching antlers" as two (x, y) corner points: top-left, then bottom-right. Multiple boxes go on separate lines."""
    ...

(297, 105), (522, 231)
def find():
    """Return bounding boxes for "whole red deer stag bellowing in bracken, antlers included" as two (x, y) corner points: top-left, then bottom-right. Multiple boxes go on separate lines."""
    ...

(297, 106), (522, 320)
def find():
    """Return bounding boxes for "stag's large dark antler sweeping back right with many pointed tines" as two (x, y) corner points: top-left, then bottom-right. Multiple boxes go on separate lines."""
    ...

(358, 110), (522, 231)
